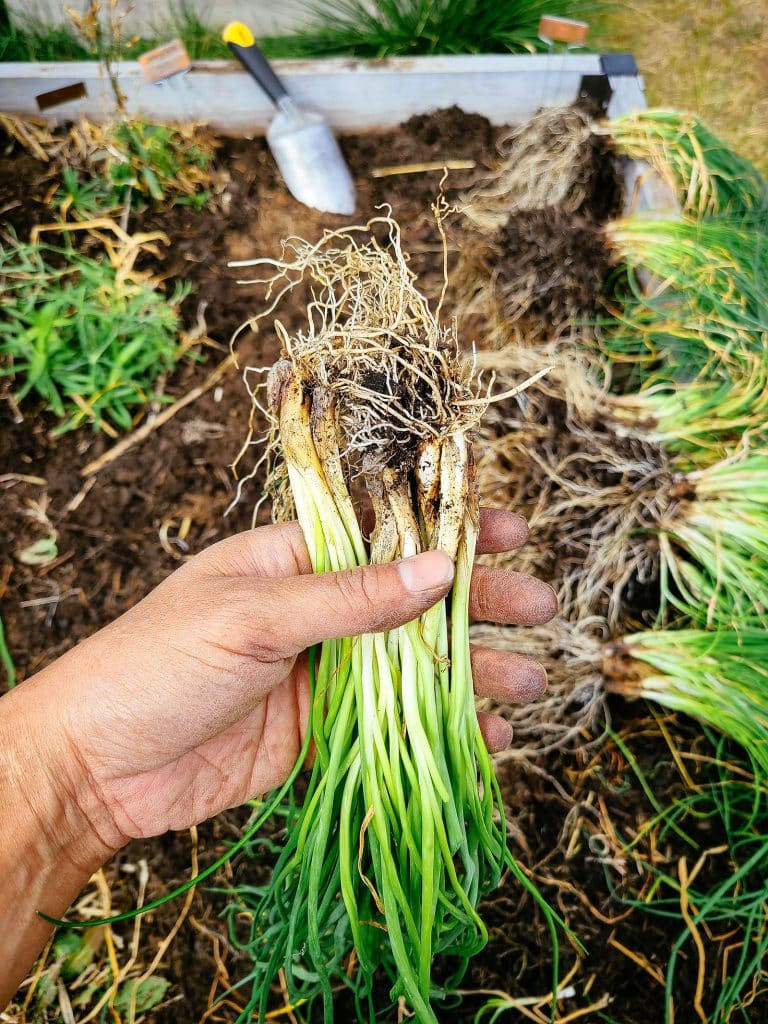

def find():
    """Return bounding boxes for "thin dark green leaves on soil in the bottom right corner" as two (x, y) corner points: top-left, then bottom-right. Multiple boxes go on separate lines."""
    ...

(625, 730), (768, 1024)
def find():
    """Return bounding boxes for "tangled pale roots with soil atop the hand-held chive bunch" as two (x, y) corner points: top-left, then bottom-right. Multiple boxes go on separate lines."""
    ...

(234, 208), (488, 524)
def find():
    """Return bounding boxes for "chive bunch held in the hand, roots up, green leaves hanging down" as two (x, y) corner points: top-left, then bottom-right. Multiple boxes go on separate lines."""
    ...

(230, 211), (552, 1024)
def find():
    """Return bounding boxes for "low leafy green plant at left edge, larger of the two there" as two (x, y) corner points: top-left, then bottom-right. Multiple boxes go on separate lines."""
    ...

(0, 244), (188, 434)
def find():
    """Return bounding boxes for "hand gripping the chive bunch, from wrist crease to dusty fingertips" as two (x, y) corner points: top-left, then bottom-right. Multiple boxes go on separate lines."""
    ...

(26, 510), (556, 847)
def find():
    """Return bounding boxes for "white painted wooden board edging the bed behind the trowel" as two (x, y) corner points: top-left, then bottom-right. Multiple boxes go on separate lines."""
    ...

(0, 53), (610, 135)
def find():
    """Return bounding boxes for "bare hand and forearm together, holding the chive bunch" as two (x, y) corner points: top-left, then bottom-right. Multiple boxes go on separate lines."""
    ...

(0, 509), (556, 1007)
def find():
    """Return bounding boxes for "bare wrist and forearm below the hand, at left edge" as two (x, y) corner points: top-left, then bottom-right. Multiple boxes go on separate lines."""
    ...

(0, 677), (114, 1010)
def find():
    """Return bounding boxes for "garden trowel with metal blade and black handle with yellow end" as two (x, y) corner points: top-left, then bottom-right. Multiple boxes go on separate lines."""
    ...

(223, 22), (355, 214)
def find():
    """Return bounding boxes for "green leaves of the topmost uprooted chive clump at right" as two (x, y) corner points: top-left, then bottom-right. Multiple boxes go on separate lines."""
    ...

(595, 110), (768, 216)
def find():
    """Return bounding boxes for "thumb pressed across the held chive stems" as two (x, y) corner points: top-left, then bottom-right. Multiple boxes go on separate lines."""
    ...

(262, 551), (454, 653)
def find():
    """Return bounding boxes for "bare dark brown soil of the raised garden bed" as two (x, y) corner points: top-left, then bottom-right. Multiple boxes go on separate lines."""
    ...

(0, 109), (768, 1024)
